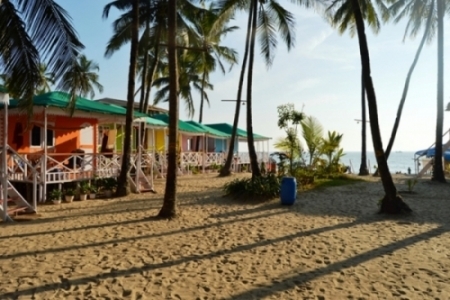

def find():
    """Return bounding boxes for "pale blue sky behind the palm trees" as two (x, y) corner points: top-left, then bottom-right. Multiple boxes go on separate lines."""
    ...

(57, 0), (450, 152)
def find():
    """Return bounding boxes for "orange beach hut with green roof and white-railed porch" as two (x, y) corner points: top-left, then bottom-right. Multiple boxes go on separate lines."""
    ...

(3, 92), (165, 206)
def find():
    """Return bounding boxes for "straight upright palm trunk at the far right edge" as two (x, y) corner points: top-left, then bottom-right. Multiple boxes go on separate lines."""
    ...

(431, 0), (445, 182)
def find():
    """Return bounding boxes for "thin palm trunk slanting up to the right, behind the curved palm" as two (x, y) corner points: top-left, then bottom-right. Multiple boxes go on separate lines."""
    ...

(385, 1), (434, 159)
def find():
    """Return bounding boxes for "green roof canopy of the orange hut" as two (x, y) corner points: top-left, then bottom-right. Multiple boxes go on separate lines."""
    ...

(9, 92), (147, 117)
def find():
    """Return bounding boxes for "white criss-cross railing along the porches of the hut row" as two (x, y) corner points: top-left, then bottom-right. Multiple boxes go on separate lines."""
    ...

(8, 151), (269, 184)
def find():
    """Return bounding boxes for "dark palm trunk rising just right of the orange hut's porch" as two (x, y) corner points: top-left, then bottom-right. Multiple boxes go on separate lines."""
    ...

(116, 0), (139, 197)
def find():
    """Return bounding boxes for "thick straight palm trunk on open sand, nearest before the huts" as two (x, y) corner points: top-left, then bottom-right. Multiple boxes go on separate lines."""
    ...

(158, 0), (179, 218)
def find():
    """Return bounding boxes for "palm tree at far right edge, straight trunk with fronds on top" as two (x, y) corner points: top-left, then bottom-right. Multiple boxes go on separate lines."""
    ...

(391, 0), (444, 182)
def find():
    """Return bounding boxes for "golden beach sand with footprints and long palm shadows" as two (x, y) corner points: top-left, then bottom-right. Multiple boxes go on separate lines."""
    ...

(0, 175), (450, 300)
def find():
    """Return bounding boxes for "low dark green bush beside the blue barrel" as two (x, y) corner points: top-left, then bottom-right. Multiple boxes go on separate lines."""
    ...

(223, 173), (281, 200)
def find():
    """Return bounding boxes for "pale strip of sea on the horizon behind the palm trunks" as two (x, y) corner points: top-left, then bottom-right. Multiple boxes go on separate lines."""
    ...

(341, 151), (415, 174)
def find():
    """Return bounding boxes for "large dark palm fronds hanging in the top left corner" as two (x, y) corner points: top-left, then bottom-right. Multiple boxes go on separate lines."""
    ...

(0, 0), (84, 113)
